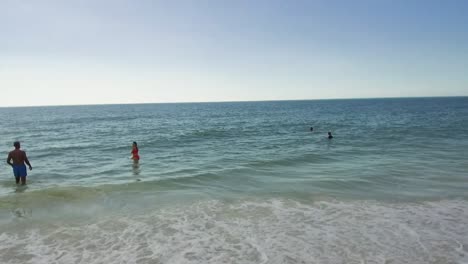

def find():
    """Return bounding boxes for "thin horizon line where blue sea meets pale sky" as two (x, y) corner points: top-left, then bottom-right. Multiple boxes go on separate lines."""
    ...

(0, 95), (468, 109)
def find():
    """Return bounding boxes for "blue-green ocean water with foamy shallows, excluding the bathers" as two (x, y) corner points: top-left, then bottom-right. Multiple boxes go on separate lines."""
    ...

(0, 97), (468, 264)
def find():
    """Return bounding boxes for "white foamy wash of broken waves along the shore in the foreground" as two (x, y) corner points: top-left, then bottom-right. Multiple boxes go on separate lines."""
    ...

(0, 199), (468, 264)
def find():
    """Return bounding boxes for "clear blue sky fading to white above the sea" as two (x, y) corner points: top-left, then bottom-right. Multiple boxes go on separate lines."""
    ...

(0, 0), (468, 107)
